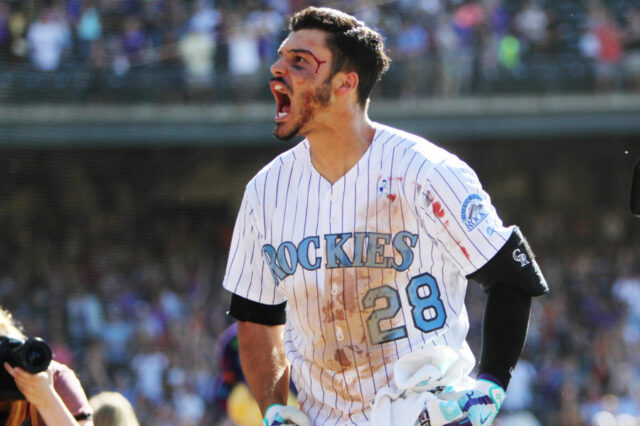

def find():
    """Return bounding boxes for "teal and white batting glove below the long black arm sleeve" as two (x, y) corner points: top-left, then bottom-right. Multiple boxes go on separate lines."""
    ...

(458, 379), (505, 426)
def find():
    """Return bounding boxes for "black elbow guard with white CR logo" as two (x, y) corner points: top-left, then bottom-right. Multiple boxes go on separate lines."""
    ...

(467, 227), (549, 297)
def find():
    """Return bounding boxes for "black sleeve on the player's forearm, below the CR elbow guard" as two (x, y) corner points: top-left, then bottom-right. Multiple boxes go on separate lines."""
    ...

(478, 285), (531, 390)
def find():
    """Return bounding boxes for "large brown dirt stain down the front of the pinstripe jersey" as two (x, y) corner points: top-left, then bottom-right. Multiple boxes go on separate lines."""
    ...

(317, 189), (412, 390)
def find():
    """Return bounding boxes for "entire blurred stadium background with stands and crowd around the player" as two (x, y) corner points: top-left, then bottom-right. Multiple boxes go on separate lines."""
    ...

(0, 0), (640, 426)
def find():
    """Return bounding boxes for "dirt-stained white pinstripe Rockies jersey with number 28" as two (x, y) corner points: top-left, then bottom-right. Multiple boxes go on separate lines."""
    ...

(224, 123), (512, 425)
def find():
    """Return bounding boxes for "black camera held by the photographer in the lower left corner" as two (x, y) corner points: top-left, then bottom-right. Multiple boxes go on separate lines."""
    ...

(0, 336), (51, 401)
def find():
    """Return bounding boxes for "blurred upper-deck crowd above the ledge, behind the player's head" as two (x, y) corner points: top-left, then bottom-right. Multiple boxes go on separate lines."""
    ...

(0, 0), (640, 102)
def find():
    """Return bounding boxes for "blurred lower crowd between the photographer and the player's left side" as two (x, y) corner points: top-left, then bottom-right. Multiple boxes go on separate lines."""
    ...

(0, 206), (234, 426)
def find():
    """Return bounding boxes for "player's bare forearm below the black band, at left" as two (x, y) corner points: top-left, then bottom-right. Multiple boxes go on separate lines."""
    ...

(238, 321), (289, 415)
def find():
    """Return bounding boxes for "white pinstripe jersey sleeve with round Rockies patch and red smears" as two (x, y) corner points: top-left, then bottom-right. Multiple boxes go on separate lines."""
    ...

(416, 156), (513, 275)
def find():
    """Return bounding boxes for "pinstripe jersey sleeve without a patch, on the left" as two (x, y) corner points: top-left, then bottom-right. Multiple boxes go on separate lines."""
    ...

(223, 187), (286, 305)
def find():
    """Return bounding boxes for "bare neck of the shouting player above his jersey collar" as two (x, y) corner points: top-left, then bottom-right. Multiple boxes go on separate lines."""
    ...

(306, 113), (375, 184)
